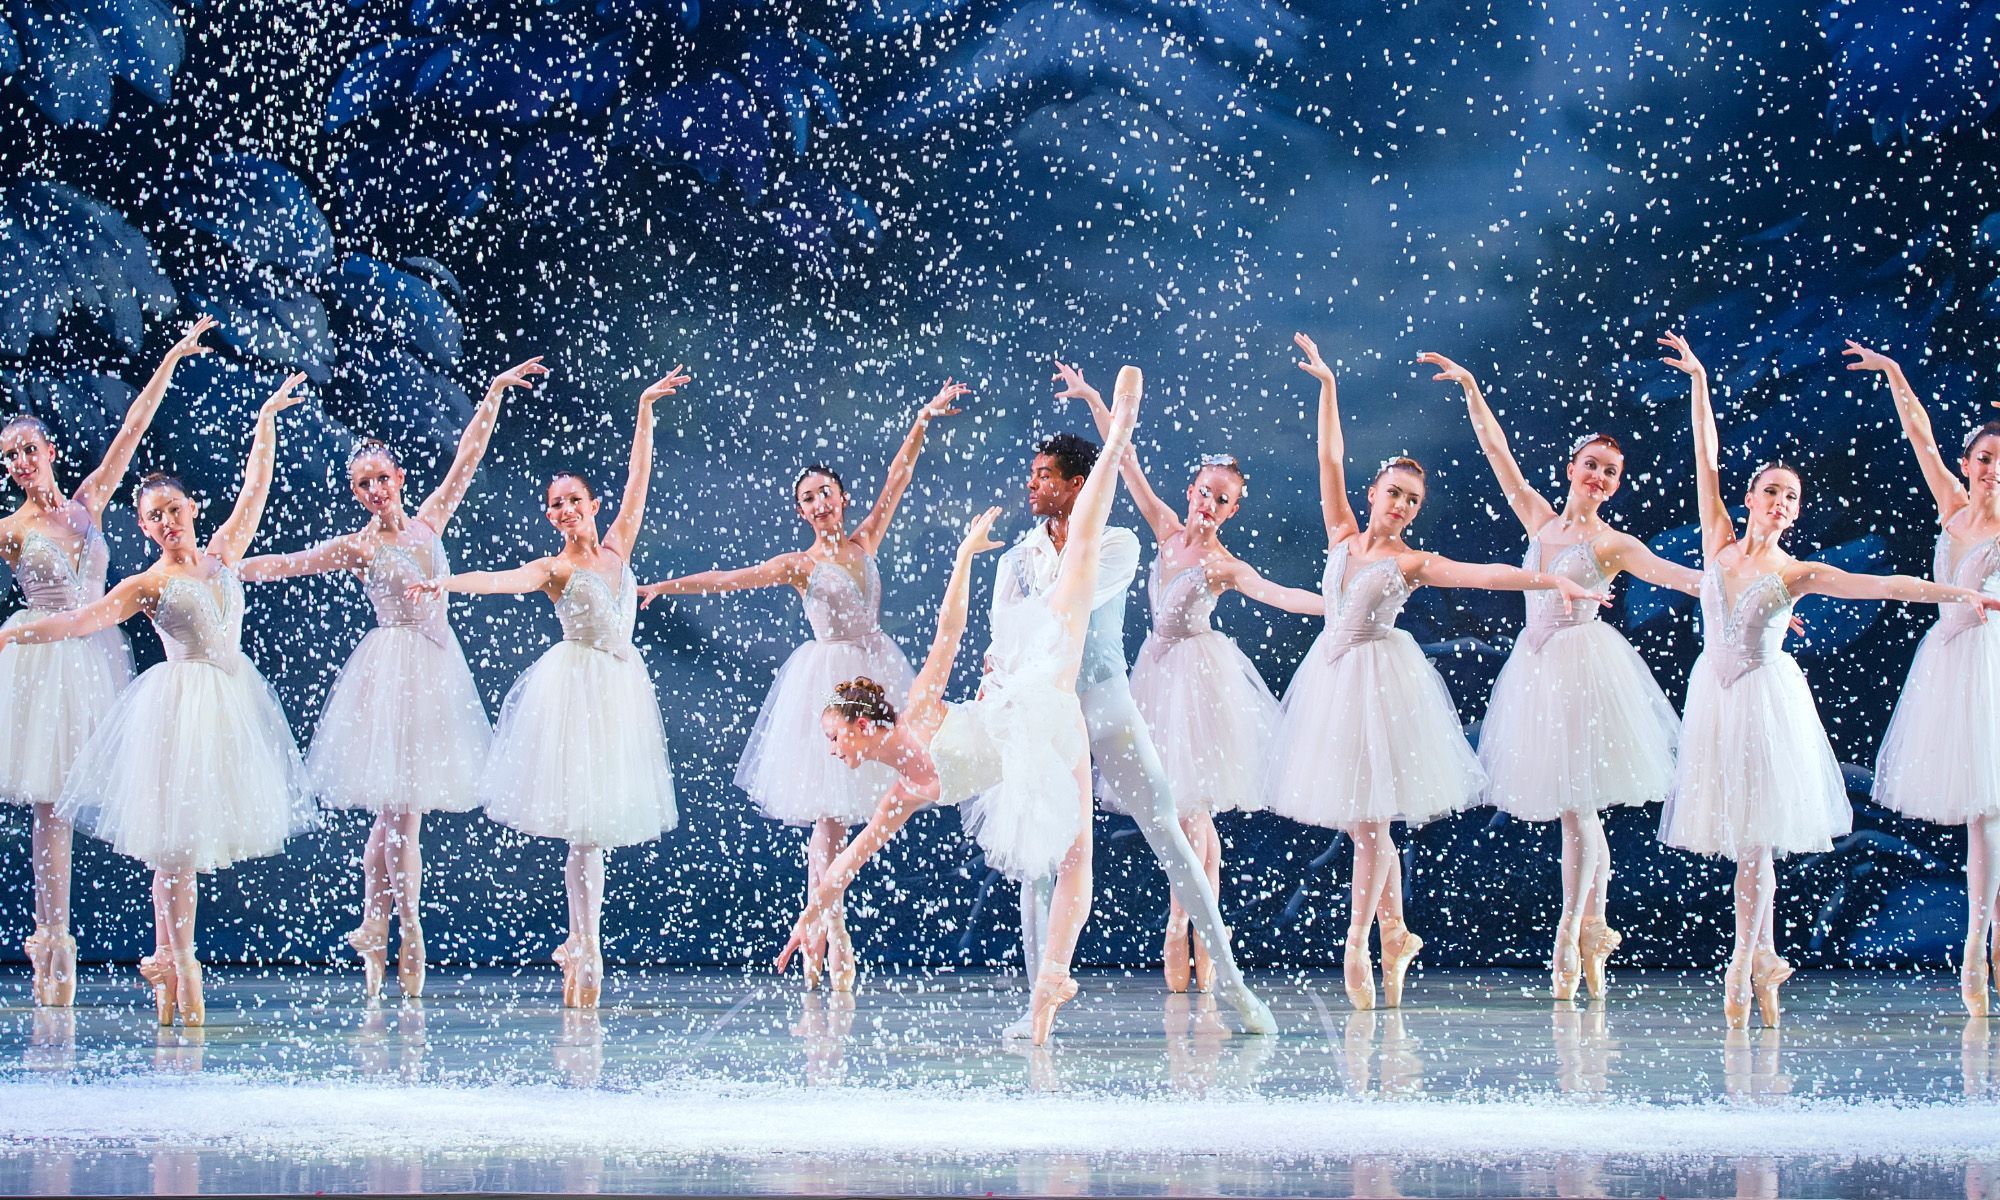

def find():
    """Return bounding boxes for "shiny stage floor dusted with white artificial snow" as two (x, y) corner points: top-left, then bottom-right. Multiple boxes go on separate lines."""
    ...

(0, 968), (2000, 1198)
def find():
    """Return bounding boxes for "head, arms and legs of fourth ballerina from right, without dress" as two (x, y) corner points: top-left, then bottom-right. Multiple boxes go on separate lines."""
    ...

(1292, 334), (1610, 1008)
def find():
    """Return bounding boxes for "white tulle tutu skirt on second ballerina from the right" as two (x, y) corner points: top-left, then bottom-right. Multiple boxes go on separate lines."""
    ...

(1660, 652), (1854, 858)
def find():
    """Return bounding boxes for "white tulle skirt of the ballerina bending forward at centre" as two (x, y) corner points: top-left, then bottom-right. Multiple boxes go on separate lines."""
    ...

(930, 686), (1090, 880)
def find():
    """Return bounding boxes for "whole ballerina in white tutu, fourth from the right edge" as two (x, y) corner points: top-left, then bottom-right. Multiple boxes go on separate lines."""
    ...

(1266, 334), (1608, 1008)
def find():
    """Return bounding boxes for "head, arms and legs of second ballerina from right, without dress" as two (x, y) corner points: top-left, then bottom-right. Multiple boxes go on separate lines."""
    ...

(1660, 334), (2000, 1028)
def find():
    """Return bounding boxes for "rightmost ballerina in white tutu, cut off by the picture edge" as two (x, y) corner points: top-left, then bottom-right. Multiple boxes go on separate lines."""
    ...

(1846, 342), (2000, 1016)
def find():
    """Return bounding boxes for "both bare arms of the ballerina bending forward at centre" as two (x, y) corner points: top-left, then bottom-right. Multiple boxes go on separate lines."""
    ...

(778, 508), (1002, 974)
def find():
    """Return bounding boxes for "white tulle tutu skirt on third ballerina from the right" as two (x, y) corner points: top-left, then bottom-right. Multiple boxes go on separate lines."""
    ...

(1480, 620), (1680, 820)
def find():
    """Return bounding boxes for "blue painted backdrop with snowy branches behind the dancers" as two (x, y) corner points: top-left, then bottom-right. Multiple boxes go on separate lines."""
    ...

(0, 0), (2000, 968)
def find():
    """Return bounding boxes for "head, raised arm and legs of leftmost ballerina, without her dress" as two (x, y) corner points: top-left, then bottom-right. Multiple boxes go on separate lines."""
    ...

(0, 316), (216, 1006)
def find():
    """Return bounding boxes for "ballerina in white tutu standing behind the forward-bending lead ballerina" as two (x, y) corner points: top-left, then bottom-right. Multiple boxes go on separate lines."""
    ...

(638, 380), (970, 992)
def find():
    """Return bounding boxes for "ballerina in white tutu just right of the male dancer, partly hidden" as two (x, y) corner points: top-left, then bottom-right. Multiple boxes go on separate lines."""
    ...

(1056, 362), (1326, 992)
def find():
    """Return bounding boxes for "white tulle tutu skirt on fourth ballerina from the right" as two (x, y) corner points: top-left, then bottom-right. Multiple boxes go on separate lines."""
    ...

(1264, 630), (1486, 830)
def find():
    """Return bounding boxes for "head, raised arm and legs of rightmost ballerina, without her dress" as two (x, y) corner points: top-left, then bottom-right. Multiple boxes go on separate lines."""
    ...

(1842, 342), (2000, 1016)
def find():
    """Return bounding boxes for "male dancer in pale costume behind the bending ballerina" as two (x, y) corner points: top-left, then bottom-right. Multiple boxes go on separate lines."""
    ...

(992, 434), (1278, 1038)
